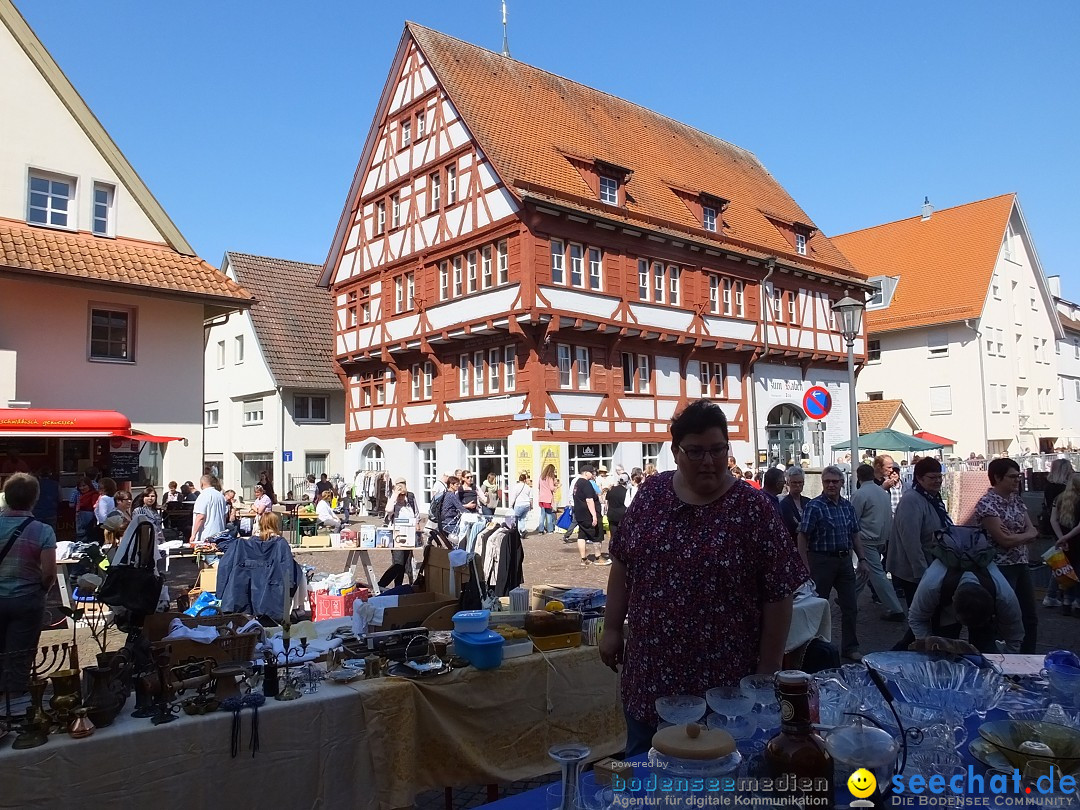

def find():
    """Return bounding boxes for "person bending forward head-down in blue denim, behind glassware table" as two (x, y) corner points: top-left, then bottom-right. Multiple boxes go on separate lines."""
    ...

(907, 559), (1024, 653)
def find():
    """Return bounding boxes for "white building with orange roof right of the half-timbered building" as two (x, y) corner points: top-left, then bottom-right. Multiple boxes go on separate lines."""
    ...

(834, 194), (1064, 456)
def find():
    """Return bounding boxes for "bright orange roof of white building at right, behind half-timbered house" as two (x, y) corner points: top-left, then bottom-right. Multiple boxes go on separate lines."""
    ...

(833, 194), (1016, 333)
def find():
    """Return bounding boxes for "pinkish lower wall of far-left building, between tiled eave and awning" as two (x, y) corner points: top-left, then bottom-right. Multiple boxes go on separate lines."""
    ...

(0, 275), (203, 481)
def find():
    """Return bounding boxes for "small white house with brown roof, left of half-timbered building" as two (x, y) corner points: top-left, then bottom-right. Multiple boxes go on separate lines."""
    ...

(203, 251), (343, 498)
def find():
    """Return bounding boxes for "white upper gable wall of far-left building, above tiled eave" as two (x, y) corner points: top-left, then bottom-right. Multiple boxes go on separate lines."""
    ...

(0, 26), (167, 240)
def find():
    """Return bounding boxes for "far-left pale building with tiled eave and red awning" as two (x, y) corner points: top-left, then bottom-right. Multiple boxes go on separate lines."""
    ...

(0, 0), (251, 501)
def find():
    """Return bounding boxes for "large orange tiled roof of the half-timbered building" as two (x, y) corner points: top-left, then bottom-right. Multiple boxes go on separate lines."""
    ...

(406, 23), (859, 278)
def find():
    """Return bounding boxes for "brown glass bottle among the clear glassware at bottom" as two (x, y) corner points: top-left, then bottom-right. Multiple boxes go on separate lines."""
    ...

(765, 670), (835, 810)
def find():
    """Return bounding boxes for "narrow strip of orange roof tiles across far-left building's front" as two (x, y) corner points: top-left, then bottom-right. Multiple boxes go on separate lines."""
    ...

(0, 219), (253, 308)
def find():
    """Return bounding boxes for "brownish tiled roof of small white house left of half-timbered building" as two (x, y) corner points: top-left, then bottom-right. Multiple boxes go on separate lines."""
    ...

(226, 251), (342, 391)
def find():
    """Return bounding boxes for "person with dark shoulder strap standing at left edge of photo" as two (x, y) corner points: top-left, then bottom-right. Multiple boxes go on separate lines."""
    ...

(0, 473), (56, 696)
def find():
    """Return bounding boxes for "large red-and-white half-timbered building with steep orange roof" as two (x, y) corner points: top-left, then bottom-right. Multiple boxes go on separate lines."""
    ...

(323, 24), (865, 501)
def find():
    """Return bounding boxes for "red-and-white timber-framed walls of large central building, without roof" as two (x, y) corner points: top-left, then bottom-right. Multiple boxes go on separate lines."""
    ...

(325, 25), (864, 451)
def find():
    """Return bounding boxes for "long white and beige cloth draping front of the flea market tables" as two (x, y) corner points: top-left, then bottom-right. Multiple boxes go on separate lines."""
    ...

(0, 647), (625, 810)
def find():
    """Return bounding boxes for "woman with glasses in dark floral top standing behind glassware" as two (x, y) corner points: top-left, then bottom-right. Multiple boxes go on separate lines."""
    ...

(599, 400), (810, 756)
